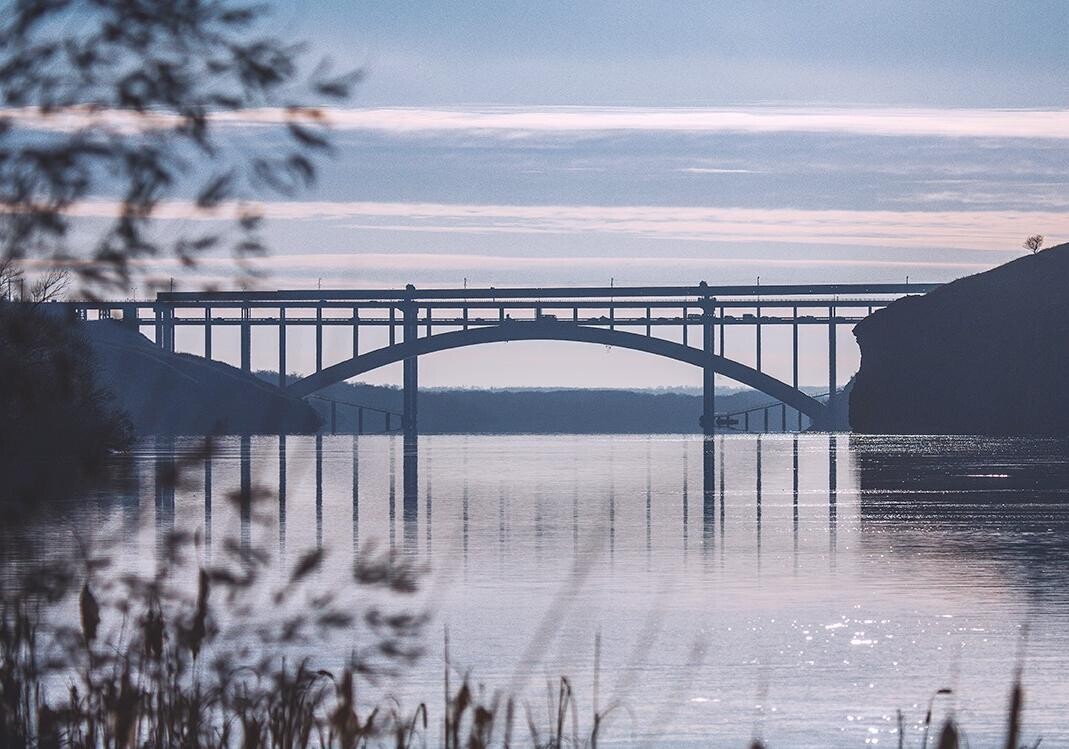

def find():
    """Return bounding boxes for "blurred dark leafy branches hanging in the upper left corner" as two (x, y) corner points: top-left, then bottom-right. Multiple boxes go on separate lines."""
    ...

(0, 0), (359, 292)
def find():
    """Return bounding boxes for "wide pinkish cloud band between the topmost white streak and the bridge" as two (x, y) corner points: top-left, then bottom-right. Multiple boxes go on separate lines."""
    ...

(60, 201), (1069, 252)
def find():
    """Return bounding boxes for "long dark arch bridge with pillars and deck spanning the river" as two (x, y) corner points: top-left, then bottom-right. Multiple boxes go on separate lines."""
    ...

(71, 281), (939, 436)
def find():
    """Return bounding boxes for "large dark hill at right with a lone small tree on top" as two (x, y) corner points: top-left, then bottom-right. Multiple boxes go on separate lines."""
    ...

(850, 245), (1069, 435)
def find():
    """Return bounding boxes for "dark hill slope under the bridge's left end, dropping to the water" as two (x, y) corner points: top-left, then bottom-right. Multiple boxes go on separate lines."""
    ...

(84, 321), (320, 435)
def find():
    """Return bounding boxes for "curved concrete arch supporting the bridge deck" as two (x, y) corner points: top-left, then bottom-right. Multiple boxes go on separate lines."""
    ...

(286, 321), (827, 423)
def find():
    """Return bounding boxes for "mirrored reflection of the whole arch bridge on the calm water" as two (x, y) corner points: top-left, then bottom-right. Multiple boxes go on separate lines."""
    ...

(153, 435), (839, 567)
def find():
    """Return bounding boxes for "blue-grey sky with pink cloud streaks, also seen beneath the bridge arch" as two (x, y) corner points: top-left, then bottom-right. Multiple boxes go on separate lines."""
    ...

(56, 0), (1069, 387)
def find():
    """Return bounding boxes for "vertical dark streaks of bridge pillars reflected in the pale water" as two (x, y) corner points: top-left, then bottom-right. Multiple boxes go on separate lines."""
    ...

(219, 435), (839, 564)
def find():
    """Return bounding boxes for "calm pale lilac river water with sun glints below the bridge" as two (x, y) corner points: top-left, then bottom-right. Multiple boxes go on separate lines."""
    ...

(7, 435), (1069, 747)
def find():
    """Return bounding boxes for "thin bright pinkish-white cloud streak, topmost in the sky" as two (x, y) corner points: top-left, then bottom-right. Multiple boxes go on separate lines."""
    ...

(6, 107), (1069, 140)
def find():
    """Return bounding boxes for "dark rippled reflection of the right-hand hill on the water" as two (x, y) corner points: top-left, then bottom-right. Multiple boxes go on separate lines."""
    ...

(850, 437), (1069, 597)
